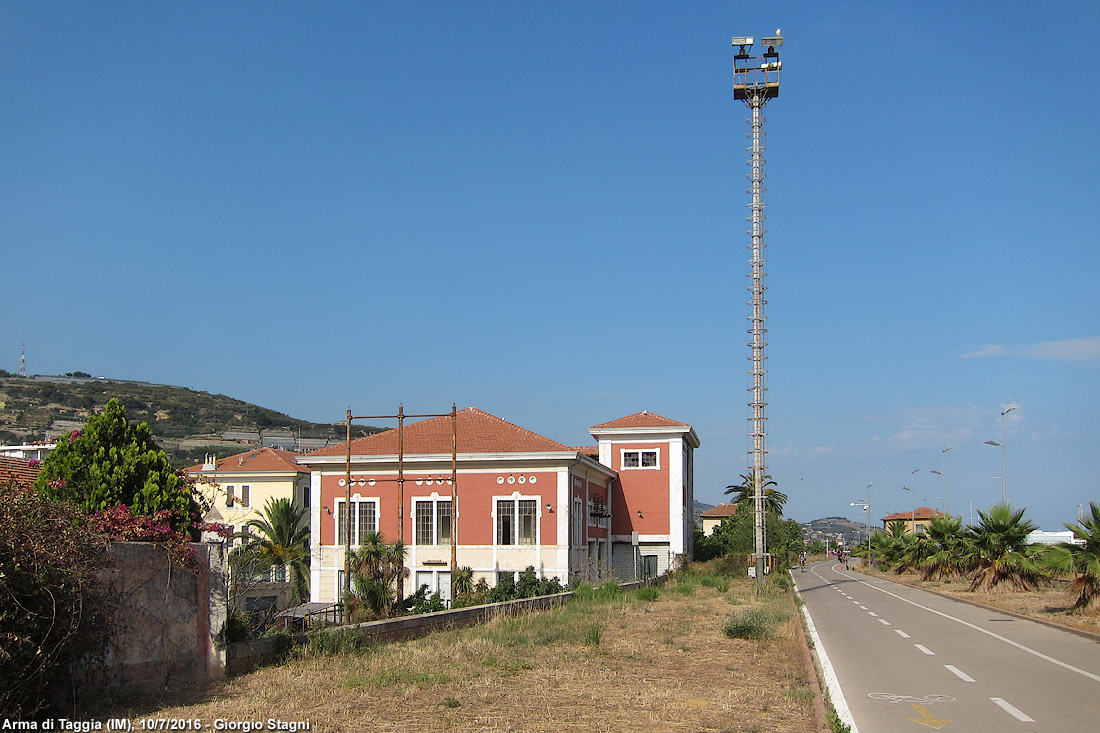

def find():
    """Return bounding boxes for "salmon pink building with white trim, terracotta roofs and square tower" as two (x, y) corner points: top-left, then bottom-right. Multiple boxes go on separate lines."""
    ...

(298, 407), (699, 602)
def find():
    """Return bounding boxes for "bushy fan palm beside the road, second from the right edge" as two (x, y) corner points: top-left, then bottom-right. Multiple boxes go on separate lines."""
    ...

(965, 504), (1044, 591)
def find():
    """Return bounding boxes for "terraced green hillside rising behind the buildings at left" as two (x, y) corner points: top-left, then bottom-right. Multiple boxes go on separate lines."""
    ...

(0, 372), (378, 464)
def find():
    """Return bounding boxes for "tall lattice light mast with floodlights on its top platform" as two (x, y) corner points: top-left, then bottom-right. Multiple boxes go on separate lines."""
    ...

(733, 30), (783, 589)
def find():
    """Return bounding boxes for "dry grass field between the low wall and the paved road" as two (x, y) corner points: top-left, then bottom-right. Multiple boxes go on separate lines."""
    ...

(95, 578), (817, 733)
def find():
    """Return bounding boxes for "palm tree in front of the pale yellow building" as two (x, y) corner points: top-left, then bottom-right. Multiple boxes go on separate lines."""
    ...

(238, 497), (309, 603)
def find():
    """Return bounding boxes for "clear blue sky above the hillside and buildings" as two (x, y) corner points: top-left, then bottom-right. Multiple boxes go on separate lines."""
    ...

(0, 0), (1100, 529)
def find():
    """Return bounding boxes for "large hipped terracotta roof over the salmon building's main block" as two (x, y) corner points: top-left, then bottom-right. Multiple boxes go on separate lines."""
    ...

(309, 407), (575, 458)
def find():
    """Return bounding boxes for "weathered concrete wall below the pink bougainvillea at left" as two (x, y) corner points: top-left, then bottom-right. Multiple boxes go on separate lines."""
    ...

(96, 543), (227, 690)
